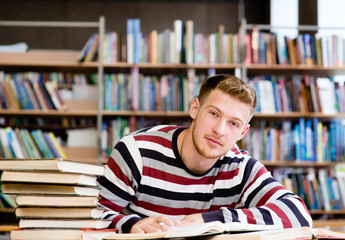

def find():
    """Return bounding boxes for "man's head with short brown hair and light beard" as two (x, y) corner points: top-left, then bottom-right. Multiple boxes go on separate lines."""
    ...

(184, 75), (257, 172)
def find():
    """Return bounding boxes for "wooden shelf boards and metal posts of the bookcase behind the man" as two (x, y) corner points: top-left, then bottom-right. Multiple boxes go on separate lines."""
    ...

(0, 11), (345, 229)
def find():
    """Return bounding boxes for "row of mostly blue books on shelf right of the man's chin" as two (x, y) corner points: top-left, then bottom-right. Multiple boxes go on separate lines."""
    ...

(241, 118), (345, 163)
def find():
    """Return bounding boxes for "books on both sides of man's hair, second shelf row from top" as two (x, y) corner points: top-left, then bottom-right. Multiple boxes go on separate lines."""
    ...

(104, 73), (345, 114)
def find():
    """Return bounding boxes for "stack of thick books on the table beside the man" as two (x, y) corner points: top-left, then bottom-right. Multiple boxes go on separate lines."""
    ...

(0, 158), (111, 239)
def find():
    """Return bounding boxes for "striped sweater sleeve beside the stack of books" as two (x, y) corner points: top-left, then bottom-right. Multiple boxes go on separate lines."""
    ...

(98, 136), (142, 233)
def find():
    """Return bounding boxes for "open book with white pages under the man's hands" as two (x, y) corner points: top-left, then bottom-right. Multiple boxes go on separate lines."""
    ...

(105, 221), (278, 239)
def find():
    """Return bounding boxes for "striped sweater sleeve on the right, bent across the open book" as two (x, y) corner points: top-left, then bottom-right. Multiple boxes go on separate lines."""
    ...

(202, 158), (312, 228)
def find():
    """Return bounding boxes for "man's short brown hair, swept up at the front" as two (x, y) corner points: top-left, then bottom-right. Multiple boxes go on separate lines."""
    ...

(198, 74), (257, 117)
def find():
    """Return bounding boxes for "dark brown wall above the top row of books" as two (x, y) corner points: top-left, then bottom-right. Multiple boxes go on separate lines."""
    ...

(0, 0), (269, 50)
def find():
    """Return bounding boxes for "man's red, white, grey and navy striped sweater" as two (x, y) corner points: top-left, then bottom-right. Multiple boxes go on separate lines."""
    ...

(98, 125), (312, 233)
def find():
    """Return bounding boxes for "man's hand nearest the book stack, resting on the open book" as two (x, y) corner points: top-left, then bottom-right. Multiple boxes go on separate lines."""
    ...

(130, 216), (180, 233)
